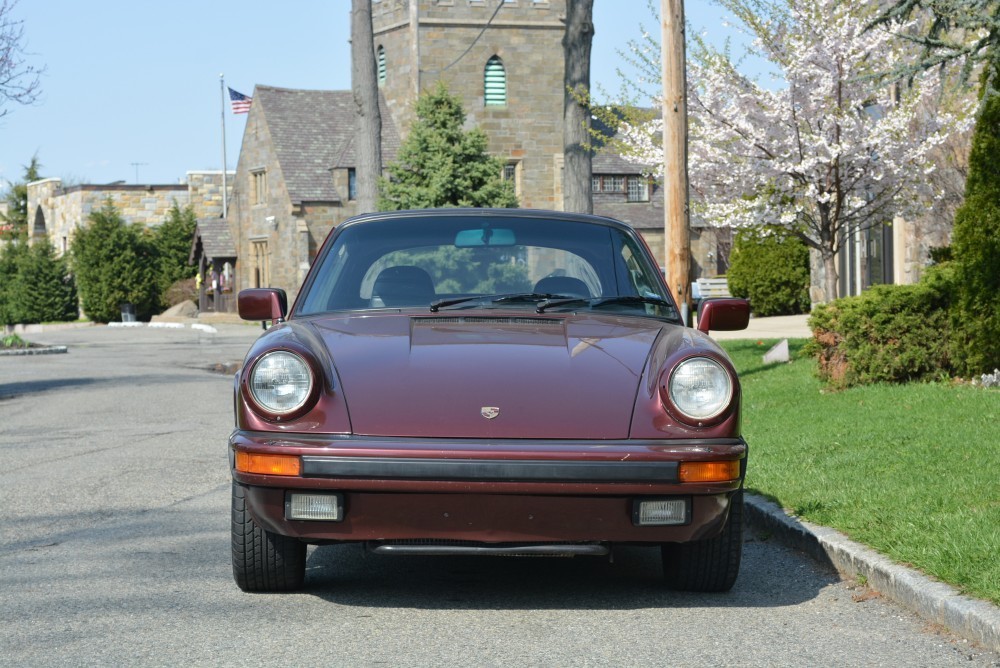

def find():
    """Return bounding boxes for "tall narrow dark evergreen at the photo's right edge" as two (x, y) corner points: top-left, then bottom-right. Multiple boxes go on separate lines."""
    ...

(951, 68), (1000, 375)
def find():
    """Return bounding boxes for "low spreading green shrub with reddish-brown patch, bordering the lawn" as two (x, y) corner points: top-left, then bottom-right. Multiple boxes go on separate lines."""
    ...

(809, 265), (954, 388)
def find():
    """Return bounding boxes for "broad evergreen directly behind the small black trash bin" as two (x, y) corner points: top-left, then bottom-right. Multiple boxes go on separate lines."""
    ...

(71, 199), (159, 322)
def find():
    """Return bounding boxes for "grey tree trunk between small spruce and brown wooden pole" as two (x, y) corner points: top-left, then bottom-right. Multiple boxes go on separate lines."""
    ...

(563, 0), (594, 213)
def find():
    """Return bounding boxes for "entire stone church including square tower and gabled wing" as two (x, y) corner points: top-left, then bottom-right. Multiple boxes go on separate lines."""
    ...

(215, 0), (719, 310)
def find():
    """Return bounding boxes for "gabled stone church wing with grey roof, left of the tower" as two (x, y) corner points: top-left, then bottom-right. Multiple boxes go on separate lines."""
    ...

(223, 86), (399, 308)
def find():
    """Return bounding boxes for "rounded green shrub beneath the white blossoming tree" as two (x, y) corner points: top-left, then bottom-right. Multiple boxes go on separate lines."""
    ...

(726, 229), (810, 316)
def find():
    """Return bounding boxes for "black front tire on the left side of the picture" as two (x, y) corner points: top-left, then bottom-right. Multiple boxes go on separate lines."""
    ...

(232, 482), (306, 591)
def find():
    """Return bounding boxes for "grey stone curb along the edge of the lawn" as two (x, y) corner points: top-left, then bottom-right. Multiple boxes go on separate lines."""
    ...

(745, 494), (1000, 652)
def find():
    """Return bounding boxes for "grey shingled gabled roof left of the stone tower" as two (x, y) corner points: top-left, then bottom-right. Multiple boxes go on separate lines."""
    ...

(253, 86), (399, 204)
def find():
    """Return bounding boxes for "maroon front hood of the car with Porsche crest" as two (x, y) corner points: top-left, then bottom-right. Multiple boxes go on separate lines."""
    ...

(309, 314), (674, 439)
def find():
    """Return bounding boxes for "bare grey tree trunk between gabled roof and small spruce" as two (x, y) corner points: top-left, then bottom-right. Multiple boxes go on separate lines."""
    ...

(352, 0), (382, 213)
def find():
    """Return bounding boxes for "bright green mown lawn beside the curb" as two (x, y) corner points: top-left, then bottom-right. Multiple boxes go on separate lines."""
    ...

(723, 339), (1000, 604)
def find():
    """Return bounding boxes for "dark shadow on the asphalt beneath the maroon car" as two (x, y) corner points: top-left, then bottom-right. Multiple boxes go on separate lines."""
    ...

(305, 533), (838, 610)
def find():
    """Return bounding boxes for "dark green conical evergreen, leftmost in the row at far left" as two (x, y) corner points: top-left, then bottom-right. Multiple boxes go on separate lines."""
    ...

(10, 239), (77, 323)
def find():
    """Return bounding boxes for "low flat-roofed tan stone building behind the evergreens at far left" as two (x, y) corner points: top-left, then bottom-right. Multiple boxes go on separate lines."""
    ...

(28, 171), (232, 255)
